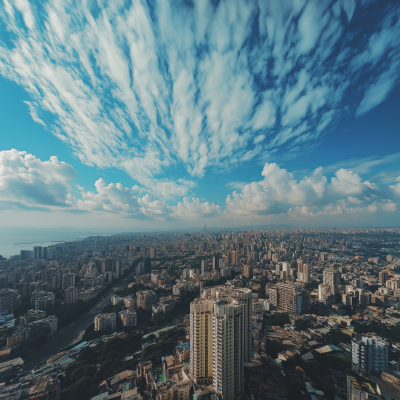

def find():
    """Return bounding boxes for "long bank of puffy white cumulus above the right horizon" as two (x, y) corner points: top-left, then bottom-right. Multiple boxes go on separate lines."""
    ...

(225, 163), (397, 217)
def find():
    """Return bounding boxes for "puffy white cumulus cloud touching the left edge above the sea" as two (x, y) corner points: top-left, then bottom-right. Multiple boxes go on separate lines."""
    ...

(0, 149), (75, 207)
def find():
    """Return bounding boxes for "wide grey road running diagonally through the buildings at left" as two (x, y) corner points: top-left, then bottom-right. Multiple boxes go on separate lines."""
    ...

(24, 271), (133, 371)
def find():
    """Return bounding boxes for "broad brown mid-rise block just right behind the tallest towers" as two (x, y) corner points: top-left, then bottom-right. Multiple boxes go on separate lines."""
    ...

(269, 283), (310, 315)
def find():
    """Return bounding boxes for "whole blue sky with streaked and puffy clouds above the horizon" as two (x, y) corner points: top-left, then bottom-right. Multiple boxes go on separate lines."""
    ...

(0, 0), (400, 231)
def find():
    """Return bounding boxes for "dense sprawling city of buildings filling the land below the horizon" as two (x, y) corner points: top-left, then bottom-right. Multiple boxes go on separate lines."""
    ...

(0, 225), (400, 400)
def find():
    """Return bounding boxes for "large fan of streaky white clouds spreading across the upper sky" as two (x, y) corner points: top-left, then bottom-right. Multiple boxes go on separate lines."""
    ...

(0, 0), (400, 191)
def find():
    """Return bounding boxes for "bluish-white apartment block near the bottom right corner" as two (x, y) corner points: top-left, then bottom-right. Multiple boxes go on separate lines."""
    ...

(351, 335), (389, 375)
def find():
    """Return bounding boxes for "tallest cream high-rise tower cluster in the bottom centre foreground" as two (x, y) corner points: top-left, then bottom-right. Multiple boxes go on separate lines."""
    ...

(190, 283), (251, 400)
